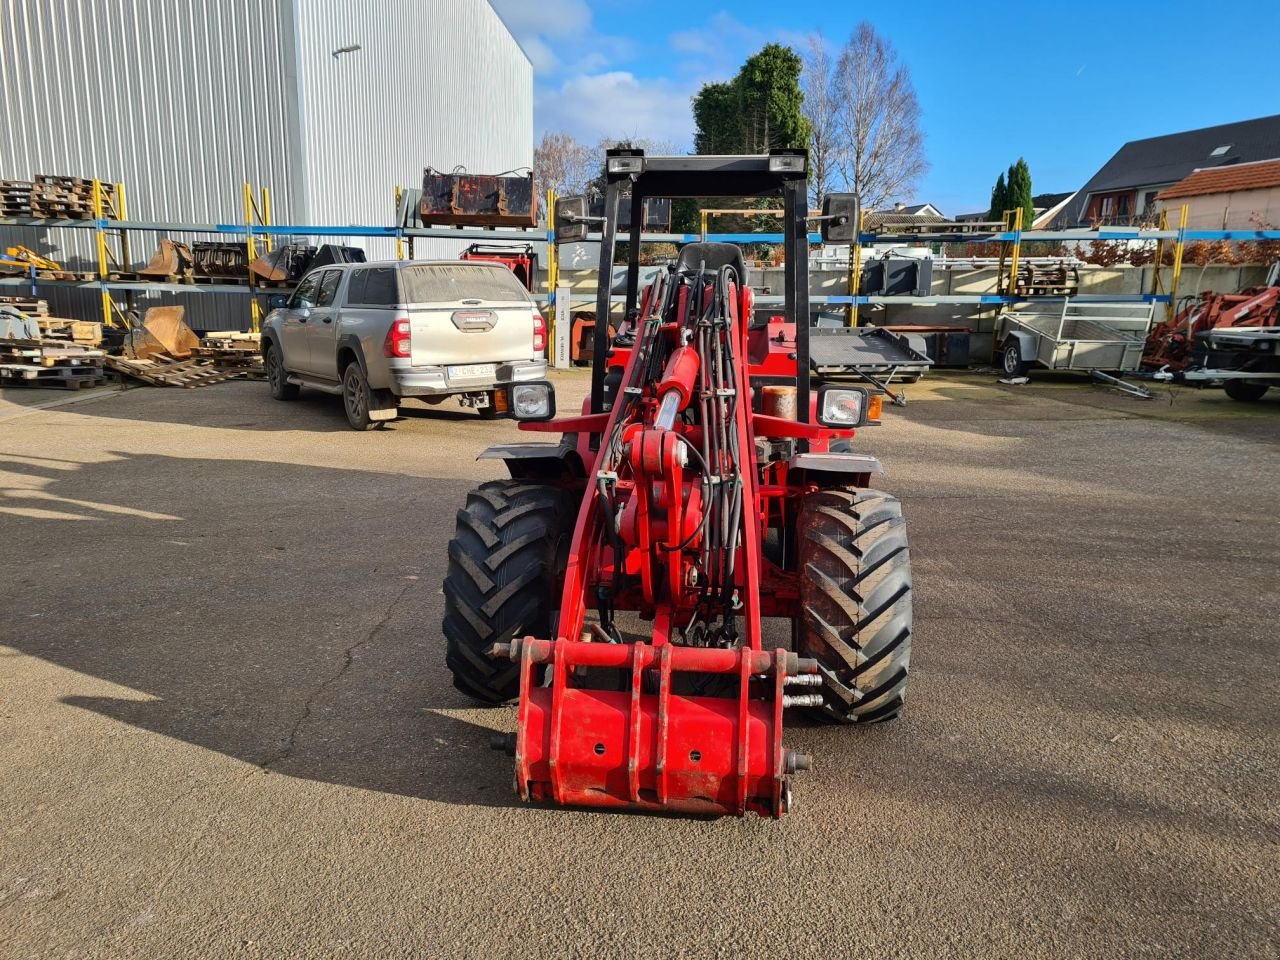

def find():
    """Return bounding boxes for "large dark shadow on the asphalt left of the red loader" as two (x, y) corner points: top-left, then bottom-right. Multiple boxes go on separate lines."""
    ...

(0, 454), (515, 805)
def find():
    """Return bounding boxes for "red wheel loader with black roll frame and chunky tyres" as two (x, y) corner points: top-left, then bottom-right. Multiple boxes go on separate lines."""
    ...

(444, 150), (911, 817)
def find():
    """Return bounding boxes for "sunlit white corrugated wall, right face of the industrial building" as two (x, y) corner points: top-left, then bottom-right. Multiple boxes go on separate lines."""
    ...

(296, 0), (534, 257)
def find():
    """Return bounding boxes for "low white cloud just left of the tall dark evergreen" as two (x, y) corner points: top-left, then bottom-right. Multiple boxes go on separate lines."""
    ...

(536, 70), (694, 148)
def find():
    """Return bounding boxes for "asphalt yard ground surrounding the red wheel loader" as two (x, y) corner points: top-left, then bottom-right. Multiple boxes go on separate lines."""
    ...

(0, 375), (1280, 957)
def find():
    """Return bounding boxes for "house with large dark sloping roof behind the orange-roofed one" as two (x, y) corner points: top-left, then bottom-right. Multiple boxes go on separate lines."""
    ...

(1055, 115), (1280, 227)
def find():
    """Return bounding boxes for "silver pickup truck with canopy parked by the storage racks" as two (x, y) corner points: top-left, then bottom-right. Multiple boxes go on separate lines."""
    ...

(262, 260), (547, 430)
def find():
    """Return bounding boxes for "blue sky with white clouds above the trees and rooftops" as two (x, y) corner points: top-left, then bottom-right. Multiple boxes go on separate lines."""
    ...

(494, 0), (1280, 215)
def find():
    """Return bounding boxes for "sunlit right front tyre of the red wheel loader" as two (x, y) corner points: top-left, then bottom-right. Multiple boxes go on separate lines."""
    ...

(795, 488), (911, 723)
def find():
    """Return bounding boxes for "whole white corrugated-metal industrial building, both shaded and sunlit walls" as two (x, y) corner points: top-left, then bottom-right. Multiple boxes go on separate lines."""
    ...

(0, 0), (532, 328)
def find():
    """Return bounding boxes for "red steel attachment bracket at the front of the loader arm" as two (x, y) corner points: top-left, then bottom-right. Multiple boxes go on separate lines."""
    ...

(495, 637), (818, 817)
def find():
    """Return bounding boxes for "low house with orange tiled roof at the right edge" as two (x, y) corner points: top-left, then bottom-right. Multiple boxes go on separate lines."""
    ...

(1156, 157), (1280, 230)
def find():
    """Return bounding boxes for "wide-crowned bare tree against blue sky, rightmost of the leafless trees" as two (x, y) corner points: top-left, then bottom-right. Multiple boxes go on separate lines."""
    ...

(833, 20), (929, 210)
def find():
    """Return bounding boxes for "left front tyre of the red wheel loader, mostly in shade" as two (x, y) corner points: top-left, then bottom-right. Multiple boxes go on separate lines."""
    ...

(444, 480), (575, 704)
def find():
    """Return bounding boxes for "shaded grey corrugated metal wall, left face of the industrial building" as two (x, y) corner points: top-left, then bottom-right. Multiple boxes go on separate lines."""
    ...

(0, 0), (301, 329)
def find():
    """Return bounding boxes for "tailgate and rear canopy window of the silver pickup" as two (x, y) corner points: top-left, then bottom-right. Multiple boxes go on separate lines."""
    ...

(401, 264), (538, 368)
